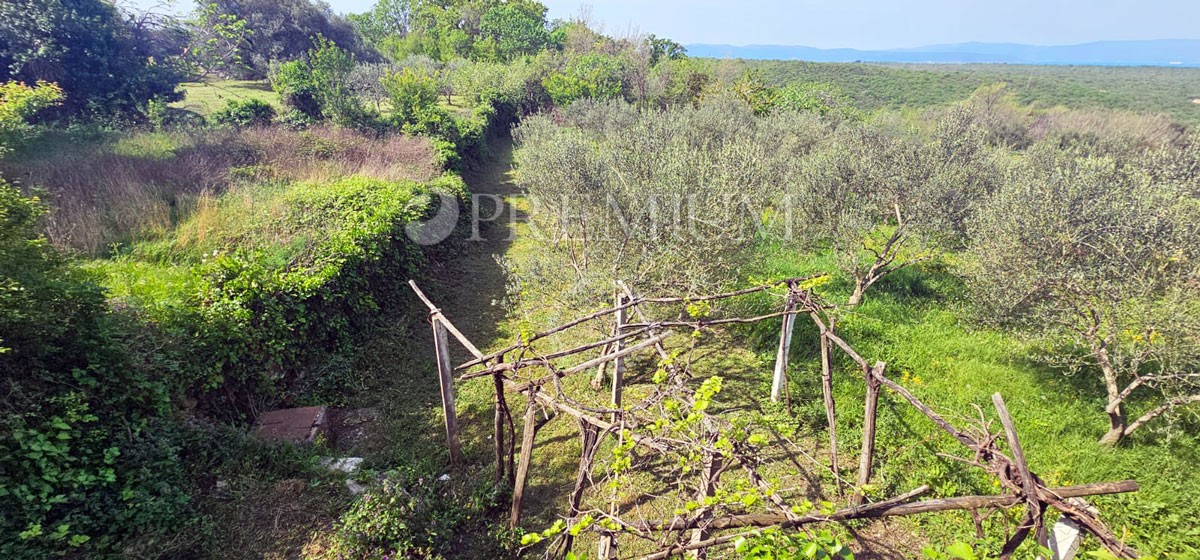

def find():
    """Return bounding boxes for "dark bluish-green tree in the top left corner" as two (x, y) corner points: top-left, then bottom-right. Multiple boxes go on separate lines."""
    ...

(0, 0), (182, 114)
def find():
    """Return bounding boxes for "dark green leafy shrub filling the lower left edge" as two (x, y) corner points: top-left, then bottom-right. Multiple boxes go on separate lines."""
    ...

(0, 183), (188, 559)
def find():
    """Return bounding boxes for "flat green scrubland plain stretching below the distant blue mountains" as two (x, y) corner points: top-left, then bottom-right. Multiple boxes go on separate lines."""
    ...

(738, 61), (1200, 125)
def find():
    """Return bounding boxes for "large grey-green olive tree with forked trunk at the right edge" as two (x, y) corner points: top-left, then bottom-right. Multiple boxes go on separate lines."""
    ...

(967, 146), (1200, 444)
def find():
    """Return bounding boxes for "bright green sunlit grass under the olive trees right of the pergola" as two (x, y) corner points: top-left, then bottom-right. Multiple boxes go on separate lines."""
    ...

(761, 248), (1200, 558)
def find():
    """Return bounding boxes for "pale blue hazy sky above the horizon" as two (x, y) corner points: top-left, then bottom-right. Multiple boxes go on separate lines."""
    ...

(133, 0), (1200, 48)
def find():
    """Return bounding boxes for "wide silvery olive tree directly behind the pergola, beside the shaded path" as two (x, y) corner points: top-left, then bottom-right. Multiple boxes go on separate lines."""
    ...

(516, 98), (812, 299)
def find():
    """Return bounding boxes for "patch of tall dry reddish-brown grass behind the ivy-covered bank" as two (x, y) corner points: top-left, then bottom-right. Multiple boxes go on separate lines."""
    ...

(2, 128), (437, 255)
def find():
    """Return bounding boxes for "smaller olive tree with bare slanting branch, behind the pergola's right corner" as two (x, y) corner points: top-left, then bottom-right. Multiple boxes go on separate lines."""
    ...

(787, 113), (994, 307)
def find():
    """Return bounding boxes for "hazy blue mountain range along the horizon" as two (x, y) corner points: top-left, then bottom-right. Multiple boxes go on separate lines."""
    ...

(686, 40), (1200, 67)
